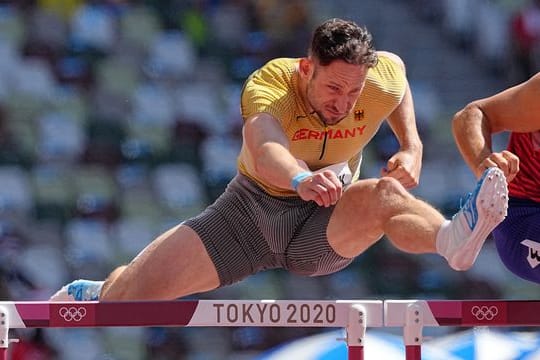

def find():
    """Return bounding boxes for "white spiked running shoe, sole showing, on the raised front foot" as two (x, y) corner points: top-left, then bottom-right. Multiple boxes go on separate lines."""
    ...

(437, 167), (508, 271)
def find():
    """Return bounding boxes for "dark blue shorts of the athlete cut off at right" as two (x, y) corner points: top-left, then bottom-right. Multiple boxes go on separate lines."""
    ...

(493, 198), (540, 283)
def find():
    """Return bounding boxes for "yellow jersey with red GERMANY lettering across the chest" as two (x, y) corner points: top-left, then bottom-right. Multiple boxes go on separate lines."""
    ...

(237, 54), (407, 196)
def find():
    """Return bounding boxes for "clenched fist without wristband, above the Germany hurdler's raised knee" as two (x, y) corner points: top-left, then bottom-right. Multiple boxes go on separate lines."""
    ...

(381, 150), (422, 189)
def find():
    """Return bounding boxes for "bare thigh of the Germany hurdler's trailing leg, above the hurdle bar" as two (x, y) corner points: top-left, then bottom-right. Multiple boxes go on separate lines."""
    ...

(101, 225), (219, 300)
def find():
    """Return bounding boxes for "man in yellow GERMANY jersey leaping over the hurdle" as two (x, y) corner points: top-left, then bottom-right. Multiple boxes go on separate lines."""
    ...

(51, 19), (508, 301)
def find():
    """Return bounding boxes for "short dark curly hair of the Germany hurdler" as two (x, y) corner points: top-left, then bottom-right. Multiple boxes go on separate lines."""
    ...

(309, 19), (378, 67)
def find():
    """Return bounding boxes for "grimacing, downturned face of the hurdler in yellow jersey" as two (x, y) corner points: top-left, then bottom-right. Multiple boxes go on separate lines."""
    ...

(301, 59), (368, 125)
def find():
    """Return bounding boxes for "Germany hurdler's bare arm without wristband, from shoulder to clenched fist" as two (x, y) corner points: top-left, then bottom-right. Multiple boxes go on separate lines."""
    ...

(381, 53), (423, 189)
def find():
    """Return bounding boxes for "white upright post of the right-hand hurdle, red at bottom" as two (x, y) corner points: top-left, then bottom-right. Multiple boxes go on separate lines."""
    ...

(403, 302), (424, 360)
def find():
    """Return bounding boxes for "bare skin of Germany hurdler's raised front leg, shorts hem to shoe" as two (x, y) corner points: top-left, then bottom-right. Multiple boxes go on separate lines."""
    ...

(327, 177), (445, 258)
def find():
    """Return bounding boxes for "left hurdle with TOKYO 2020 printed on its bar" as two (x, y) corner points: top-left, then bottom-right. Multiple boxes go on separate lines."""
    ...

(0, 300), (383, 360)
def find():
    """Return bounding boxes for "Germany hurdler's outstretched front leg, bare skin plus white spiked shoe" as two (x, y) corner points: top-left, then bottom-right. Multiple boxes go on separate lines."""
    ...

(327, 168), (508, 270)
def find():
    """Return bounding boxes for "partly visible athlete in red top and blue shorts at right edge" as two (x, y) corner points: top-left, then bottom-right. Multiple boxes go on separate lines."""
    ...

(453, 73), (540, 283)
